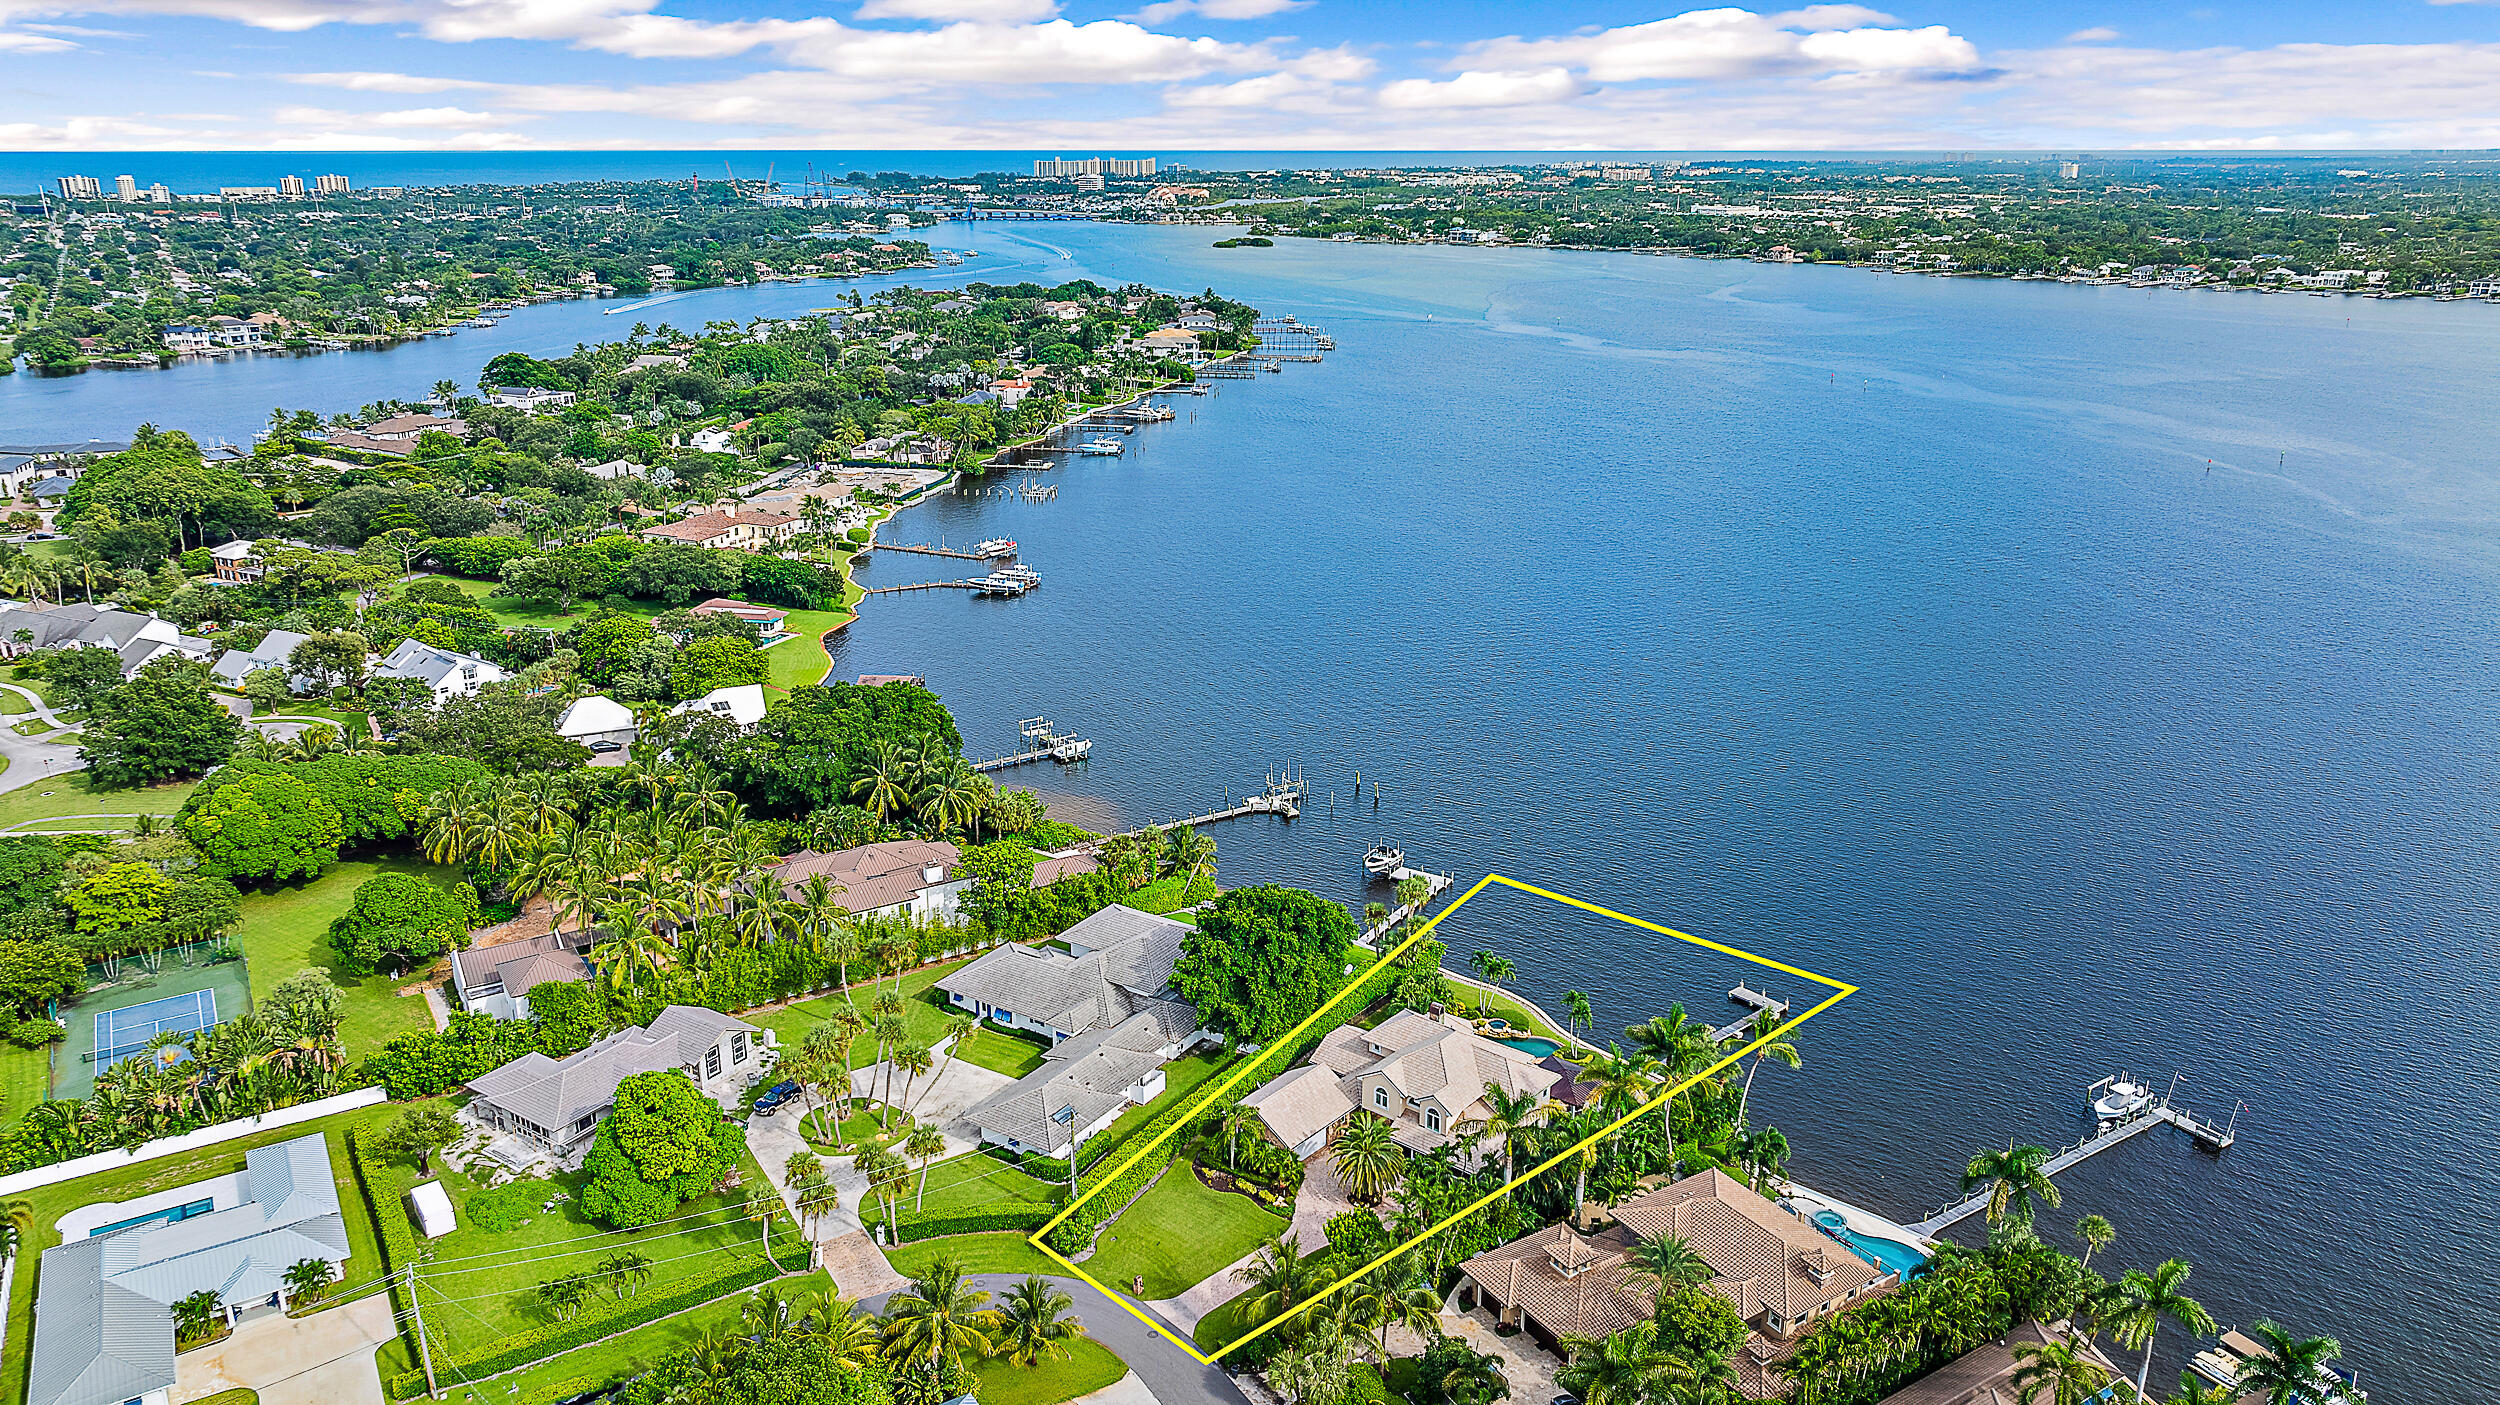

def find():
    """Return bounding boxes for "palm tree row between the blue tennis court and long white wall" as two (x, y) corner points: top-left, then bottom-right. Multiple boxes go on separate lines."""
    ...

(0, 978), (348, 1170)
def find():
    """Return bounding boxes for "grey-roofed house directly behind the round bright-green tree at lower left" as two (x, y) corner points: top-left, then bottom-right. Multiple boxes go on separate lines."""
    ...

(463, 1005), (770, 1163)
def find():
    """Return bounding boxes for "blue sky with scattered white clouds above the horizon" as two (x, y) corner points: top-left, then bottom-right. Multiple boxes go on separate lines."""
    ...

(0, 0), (2500, 153)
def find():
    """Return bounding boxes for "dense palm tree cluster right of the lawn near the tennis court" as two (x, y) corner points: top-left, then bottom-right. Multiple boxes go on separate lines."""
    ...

(418, 753), (965, 1015)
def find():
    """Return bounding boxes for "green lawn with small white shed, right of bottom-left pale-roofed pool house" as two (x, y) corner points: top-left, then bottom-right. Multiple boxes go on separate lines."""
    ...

(365, 1140), (808, 1380)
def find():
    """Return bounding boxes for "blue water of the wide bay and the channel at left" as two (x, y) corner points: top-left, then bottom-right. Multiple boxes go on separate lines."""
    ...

(0, 225), (2500, 1405)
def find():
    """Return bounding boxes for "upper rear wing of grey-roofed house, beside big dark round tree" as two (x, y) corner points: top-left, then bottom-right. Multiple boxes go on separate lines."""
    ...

(938, 903), (1198, 1043)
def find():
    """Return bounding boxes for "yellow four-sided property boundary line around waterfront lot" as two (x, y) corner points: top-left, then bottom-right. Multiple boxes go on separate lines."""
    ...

(1030, 873), (1858, 1365)
